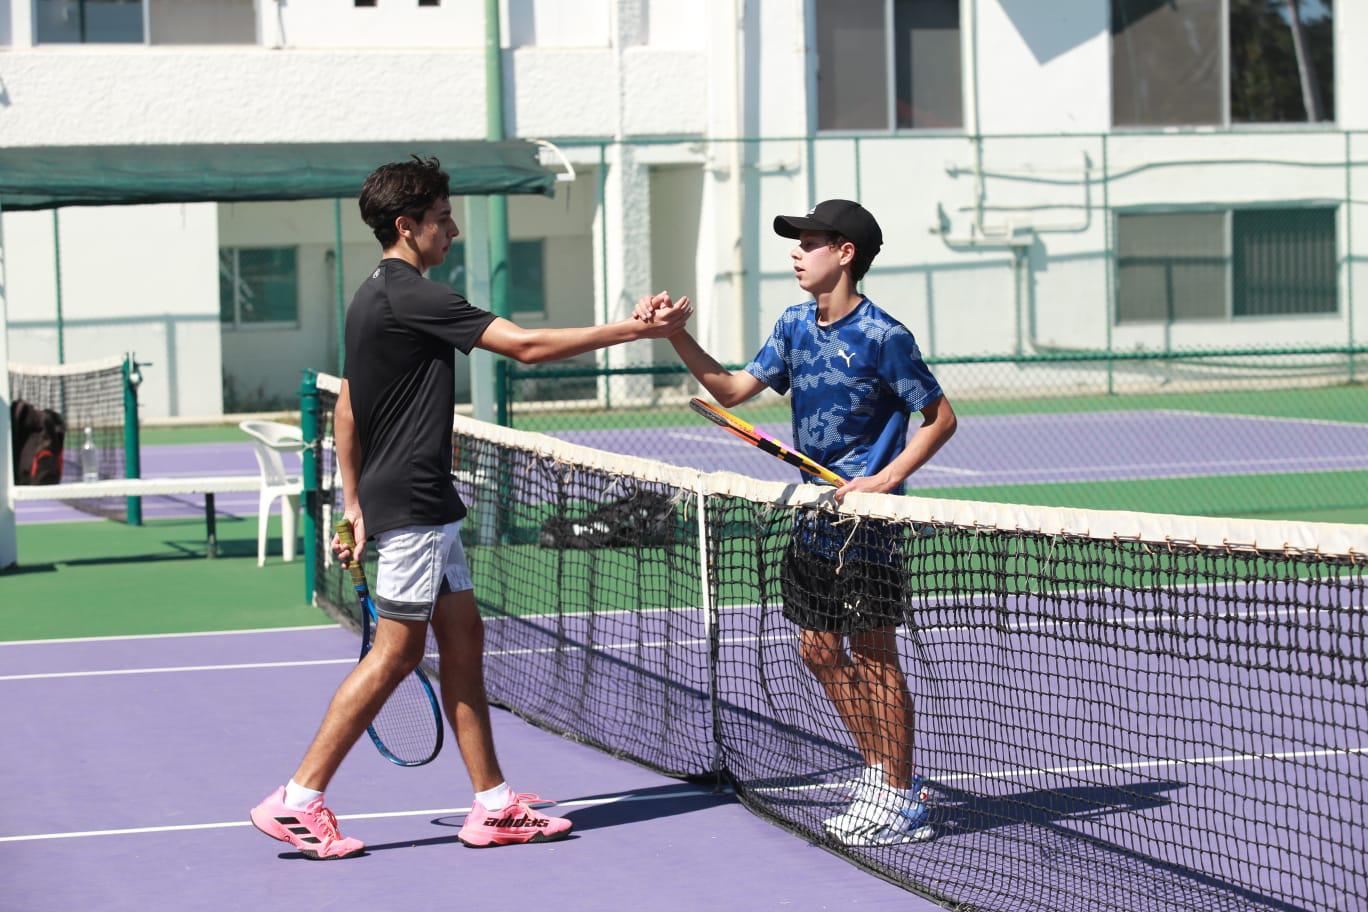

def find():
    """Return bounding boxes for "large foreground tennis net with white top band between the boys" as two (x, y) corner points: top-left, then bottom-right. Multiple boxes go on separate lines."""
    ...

(305, 377), (1368, 911)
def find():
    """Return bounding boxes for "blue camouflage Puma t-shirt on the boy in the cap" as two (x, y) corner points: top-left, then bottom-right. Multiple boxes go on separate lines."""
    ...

(746, 298), (941, 494)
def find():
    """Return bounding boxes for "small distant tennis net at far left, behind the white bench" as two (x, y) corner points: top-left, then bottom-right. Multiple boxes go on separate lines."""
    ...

(8, 356), (137, 518)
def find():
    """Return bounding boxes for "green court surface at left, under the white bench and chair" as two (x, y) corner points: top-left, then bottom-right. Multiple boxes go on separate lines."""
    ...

(0, 515), (330, 640)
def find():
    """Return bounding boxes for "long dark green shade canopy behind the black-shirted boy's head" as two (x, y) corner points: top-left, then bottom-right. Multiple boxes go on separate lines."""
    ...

(0, 139), (555, 211)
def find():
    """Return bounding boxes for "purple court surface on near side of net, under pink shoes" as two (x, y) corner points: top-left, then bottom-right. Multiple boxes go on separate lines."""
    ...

(0, 628), (933, 912)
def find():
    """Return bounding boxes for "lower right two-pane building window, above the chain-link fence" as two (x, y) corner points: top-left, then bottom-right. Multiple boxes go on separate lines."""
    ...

(1116, 208), (1338, 323)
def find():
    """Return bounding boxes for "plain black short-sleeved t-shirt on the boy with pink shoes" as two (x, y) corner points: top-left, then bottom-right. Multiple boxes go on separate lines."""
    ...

(346, 260), (494, 536)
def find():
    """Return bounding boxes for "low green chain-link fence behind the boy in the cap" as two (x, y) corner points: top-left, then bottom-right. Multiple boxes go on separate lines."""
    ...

(499, 347), (1368, 522)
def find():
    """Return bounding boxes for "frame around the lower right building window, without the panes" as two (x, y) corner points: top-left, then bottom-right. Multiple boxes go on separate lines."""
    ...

(1109, 200), (1346, 328)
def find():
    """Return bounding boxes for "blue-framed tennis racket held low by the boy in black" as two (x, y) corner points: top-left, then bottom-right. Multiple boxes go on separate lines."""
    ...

(335, 517), (443, 766)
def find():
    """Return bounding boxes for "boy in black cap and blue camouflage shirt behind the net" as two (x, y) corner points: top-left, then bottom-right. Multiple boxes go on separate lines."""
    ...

(635, 200), (955, 846)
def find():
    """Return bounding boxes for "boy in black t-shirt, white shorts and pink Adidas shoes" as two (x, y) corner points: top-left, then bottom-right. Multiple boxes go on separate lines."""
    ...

(252, 157), (691, 859)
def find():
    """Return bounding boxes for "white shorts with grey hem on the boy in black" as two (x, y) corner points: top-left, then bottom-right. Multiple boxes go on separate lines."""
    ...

(375, 521), (475, 621)
